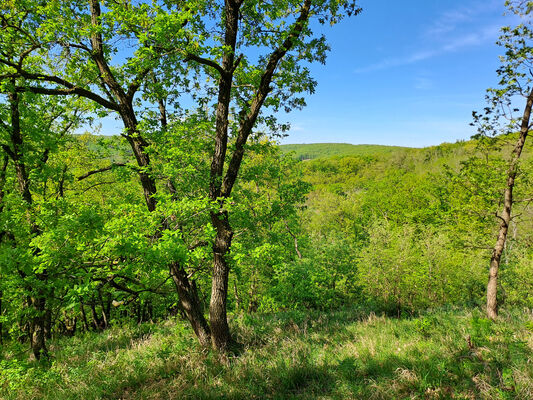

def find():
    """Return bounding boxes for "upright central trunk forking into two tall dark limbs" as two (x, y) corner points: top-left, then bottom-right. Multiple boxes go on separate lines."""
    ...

(207, 0), (311, 351)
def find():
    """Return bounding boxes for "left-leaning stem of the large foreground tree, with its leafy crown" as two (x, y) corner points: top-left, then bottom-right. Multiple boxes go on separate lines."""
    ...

(0, 0), (216, 345)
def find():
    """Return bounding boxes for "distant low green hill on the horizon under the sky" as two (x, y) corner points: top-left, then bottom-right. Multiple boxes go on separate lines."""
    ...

(280, 143), (407, 160)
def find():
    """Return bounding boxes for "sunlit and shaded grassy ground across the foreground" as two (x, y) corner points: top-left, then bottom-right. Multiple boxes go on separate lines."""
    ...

(0, 310), (533, 400)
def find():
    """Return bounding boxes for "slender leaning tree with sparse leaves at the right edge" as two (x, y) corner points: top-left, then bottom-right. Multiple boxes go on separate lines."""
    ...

(473, 1), (533, 320)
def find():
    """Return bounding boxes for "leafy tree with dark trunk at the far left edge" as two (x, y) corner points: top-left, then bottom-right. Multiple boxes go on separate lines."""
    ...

(0, 86), (84, 359)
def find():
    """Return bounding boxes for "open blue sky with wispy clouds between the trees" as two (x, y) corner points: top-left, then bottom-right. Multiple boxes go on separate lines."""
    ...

(281, 0), (516, 147)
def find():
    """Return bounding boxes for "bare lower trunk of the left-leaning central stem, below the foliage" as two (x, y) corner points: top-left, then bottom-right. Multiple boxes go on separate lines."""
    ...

(170, 263), (211, 347)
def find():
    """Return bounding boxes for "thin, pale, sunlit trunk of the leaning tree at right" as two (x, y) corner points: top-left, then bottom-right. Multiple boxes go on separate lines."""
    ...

(487, 89), (533, 320)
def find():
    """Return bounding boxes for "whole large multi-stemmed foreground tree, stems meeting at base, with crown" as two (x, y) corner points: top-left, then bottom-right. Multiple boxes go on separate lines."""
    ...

(0, 0), (359, 350)
